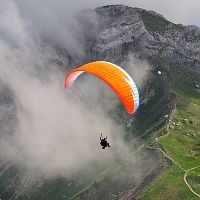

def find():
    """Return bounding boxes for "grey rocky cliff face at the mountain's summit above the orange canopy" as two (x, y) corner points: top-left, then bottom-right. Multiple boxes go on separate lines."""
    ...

(82, 5), (200, 72)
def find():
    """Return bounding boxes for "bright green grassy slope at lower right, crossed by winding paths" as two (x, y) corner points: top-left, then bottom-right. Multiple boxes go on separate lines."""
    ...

(138, 61), (200, 200)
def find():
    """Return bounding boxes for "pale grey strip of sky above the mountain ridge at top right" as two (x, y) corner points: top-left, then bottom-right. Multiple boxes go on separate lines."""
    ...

(88, 0), (200, 26)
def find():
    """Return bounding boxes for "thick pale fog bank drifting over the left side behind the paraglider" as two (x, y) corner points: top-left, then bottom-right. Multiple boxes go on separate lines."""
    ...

(0, 0), (148, 181)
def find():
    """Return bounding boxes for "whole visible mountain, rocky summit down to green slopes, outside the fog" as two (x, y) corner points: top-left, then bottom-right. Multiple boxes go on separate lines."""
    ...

(0, 5), (200, 200)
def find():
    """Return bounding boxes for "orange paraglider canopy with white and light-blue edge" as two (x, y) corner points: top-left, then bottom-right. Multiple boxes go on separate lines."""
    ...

(64, 61), (139, 114)
